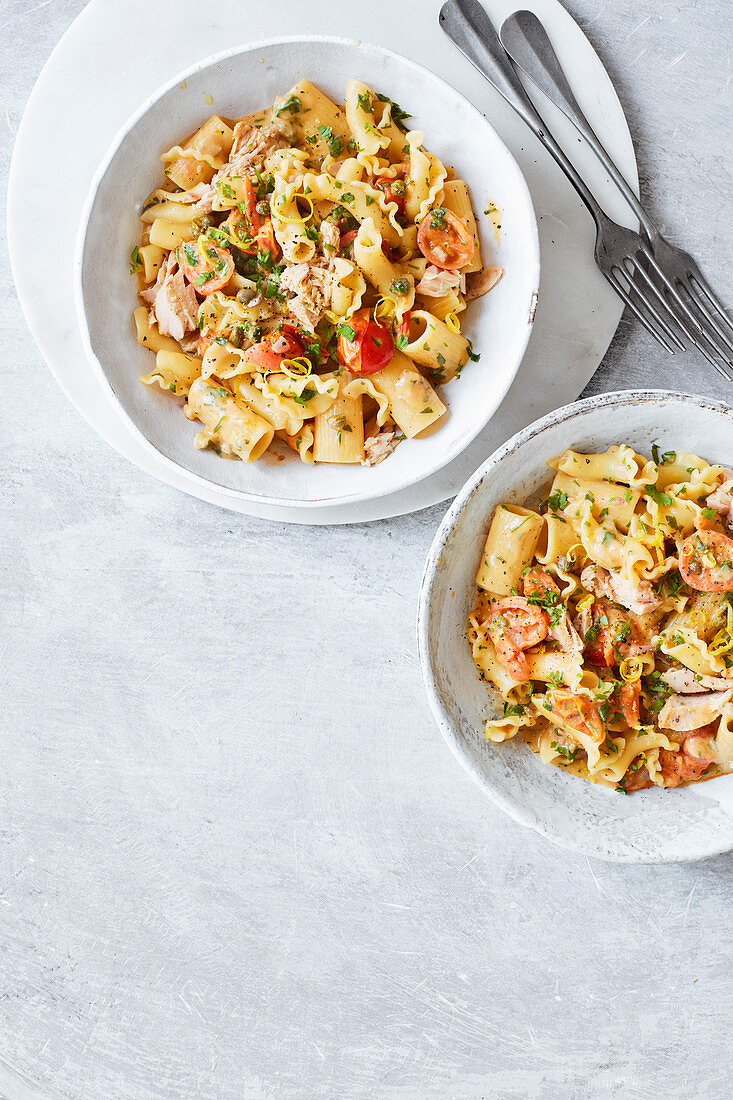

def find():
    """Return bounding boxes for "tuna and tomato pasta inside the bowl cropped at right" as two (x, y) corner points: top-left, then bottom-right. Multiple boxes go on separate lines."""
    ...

(468, 444), (733, 793)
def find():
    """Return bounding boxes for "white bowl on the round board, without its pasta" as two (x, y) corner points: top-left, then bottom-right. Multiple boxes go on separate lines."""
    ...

(76, 36), (539, 507)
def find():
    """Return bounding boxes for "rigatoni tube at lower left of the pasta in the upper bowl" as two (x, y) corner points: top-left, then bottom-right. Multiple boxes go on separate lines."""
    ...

(184, 378), (275, 462)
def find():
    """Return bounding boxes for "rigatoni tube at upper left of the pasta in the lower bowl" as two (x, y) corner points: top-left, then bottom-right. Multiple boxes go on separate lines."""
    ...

(475, 504), (544, 596)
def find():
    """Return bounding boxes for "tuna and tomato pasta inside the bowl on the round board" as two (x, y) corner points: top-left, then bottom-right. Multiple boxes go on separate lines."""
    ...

(131, 80), (502, 465)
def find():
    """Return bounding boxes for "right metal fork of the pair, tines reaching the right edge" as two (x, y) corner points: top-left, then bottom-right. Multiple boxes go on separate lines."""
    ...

(500, 11), (733, 378)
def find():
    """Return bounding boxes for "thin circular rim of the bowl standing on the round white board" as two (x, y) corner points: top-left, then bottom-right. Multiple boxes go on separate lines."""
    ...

(74, 34), (540, 508)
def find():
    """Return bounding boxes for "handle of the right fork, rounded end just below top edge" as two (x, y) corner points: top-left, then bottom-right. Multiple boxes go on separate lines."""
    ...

(500, 11), (657, 241)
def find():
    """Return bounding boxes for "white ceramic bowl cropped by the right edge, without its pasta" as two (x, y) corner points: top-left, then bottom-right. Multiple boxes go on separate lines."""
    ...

(417, 391), (733, 864)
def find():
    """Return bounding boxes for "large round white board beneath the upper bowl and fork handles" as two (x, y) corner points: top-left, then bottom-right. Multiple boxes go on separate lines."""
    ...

(8, 0), (637, 523)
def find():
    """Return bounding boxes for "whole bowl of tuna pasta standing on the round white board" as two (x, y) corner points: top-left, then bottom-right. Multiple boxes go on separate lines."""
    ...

(77, 39), (538, 507)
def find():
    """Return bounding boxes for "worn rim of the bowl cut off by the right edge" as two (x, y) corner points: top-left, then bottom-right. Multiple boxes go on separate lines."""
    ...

(416, 389), (733, 866)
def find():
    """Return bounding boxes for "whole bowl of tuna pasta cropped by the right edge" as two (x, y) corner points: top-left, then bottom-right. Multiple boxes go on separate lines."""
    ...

(418, 391), (733, 862)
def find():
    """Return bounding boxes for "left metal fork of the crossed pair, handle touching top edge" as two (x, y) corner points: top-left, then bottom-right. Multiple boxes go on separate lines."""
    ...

(438, 0), (733, 370)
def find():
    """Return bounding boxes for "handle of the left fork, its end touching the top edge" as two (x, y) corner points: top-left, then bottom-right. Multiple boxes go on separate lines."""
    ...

(438, 0), (608, 229)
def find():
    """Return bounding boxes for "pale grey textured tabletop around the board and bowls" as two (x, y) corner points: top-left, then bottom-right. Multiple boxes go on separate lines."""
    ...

(0, 0), (733, 1100)
